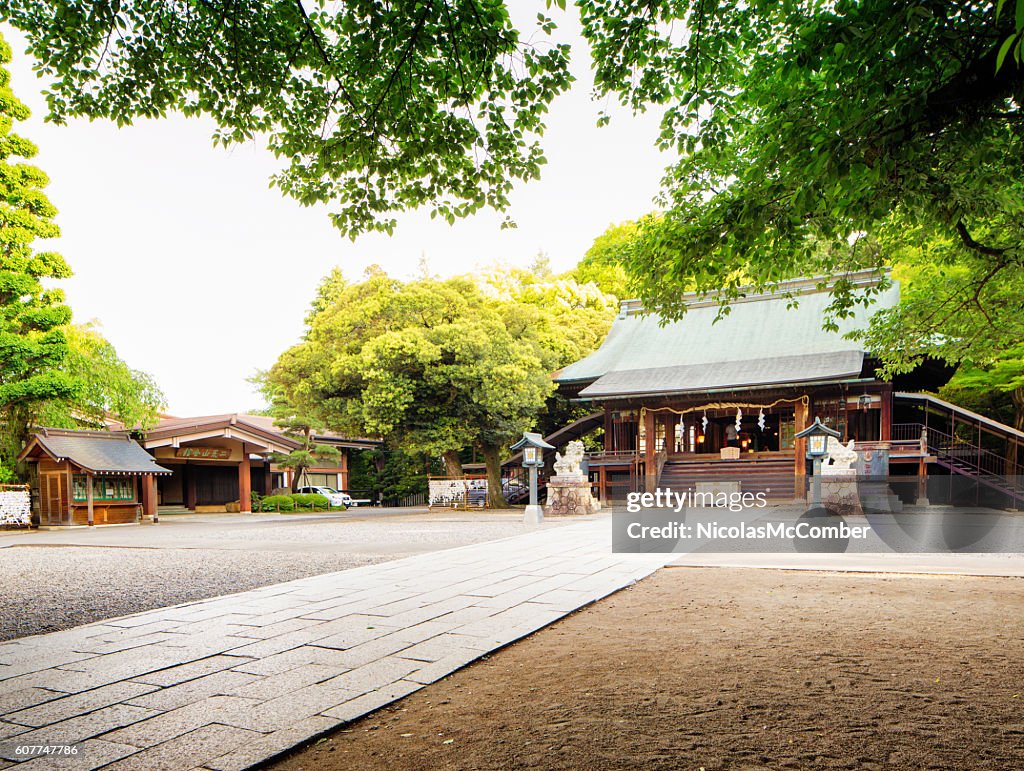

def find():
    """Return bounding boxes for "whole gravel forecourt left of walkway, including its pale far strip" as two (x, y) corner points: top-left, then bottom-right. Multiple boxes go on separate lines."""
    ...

(0, 514), (558, 640)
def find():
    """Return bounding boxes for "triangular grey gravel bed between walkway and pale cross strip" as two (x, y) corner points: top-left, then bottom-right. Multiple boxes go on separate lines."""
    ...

(0, 547), (387, 640)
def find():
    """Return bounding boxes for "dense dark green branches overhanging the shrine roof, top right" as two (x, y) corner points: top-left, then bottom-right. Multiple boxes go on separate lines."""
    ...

(583, 0), (1024, 325)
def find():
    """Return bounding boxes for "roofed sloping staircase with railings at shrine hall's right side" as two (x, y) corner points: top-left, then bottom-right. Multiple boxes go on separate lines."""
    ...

(892, 393), (1024, 506)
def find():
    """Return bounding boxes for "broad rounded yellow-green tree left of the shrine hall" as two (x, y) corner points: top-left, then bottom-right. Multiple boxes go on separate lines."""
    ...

(266, 269), (613, 505)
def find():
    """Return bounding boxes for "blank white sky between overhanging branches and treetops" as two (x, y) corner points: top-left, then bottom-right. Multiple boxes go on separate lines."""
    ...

(2, 13), (670, 416)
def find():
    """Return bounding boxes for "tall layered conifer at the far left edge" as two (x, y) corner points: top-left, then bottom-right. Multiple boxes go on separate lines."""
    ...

(0, 38), (81, 481)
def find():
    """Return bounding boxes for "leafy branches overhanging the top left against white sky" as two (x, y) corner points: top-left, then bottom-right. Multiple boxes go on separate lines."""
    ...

(0, 0), (572, 235)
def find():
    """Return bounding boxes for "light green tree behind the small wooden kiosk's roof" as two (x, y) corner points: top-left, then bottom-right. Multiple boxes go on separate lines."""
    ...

(36, 324), (166, 428)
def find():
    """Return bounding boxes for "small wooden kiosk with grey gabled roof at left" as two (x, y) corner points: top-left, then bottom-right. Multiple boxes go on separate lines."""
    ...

(18, 429), (171, 527)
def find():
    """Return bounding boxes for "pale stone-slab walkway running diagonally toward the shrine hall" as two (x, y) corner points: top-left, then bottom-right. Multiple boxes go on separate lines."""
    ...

(0, 518), (673, 771)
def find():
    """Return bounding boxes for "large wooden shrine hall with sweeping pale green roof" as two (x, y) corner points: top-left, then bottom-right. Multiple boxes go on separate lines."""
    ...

(555, 271), (948, 499)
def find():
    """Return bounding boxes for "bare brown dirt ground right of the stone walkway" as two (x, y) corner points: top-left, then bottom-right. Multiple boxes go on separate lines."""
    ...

(272, 568), (1024, 771)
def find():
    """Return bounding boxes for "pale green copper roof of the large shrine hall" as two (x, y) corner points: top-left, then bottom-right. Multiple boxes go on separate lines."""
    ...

(556, 274), (899, 396)
